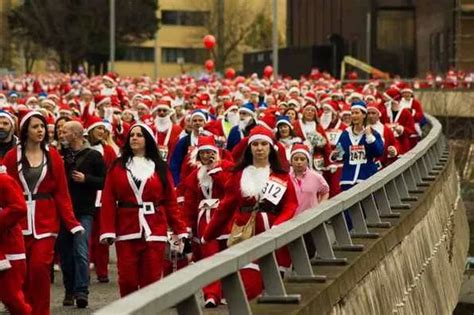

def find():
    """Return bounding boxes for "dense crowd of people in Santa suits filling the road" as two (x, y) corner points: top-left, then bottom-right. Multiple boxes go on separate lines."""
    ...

(0, 73), (426, 314)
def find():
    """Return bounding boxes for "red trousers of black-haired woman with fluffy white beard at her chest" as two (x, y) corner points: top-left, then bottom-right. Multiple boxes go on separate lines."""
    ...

(115, 239), (166, 297)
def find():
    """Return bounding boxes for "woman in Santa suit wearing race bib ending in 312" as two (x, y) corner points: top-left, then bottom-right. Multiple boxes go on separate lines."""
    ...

(201, 126), (298, 299)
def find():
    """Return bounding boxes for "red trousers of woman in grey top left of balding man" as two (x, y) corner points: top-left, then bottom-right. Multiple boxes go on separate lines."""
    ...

(25, 236), (56, 315)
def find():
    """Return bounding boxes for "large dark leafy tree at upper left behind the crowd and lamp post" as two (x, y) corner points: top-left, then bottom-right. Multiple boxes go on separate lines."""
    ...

(8, 0), (159, 73)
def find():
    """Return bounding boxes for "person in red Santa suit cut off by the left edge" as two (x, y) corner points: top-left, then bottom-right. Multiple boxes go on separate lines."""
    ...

(0, 165), (31, 315)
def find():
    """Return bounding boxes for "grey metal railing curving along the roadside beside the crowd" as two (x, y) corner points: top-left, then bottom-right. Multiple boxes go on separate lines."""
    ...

(96, 115), (447, 315)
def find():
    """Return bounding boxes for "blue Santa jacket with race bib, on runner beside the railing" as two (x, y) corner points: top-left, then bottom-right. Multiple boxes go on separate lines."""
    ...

(338, 127), (384, 185)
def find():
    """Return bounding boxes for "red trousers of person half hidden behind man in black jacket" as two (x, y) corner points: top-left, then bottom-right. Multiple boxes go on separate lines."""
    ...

(90, 215), (109, 278)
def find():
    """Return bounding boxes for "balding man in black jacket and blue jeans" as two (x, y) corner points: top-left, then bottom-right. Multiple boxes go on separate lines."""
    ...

(58, 121), (106, 308)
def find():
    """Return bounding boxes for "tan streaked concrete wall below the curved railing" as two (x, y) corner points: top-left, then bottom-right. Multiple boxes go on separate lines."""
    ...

(329, 158), (469, 315)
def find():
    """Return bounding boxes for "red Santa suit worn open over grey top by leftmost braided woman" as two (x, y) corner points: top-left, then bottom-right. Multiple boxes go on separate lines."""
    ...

(3, 146), (84, 314)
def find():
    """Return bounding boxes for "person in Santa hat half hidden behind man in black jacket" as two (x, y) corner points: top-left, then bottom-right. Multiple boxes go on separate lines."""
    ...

(85, 116), (117, 283)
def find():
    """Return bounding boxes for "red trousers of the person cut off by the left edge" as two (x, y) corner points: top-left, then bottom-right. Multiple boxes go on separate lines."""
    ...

(0, 260), (31, 315)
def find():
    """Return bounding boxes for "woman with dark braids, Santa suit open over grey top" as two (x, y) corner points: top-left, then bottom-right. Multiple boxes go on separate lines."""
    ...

(3, 111), (84, 314)
